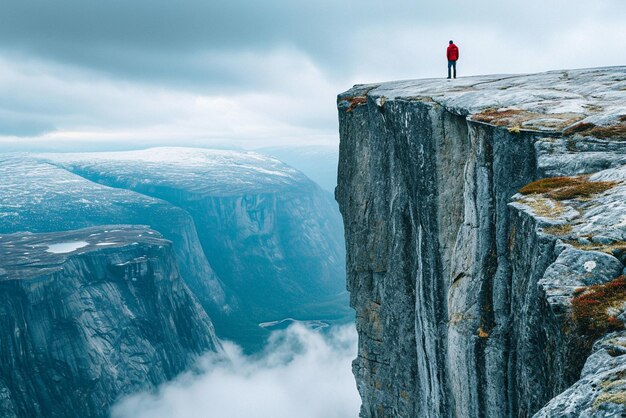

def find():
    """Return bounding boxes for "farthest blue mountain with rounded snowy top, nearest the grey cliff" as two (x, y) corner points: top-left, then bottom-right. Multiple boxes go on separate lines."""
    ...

(37, 148), (350, 343)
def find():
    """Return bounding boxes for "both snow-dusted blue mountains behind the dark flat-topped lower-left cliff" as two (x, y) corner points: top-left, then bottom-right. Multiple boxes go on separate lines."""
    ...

(0, 147), (351, 347)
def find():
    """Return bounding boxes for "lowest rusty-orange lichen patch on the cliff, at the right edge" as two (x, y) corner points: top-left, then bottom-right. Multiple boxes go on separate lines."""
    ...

(572, 276), (626, 338)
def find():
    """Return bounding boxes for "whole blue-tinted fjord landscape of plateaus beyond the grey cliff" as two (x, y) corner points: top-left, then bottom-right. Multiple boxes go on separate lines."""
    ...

(0, 148), (352, 416)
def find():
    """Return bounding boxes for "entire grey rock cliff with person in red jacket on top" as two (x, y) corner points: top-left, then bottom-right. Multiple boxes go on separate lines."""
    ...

(336, 68), (626, 417)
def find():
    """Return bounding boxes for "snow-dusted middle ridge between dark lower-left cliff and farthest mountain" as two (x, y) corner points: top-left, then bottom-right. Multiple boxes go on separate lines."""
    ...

(0, 155), (229, 330)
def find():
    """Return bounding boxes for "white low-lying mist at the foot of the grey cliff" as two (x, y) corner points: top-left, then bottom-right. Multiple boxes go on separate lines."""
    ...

(112, 325), (360, 418)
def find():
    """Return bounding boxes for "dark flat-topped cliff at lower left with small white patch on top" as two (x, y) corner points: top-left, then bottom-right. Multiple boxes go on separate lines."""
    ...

(0, 225), (219, 417)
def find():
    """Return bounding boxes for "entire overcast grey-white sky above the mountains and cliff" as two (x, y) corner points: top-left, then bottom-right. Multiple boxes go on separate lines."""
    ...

(0, 0), (626, 150)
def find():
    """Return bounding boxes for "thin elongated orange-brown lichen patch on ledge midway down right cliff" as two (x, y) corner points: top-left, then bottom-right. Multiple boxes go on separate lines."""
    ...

(519, 176), (619, 200)
